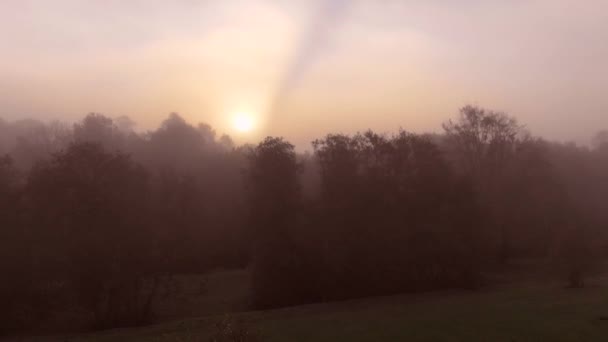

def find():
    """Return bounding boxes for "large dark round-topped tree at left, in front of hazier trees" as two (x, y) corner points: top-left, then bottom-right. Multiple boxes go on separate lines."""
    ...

(27, 143), (159, 327)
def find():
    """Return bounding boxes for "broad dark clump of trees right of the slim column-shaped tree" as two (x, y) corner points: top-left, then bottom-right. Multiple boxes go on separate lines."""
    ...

(312, 131), (479, 298)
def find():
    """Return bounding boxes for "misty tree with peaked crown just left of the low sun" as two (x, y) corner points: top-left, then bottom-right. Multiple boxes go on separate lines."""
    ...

(143, 113), (247, 272)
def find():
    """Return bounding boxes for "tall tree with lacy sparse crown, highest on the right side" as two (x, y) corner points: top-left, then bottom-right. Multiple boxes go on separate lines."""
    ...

(443, 106), (551, 263)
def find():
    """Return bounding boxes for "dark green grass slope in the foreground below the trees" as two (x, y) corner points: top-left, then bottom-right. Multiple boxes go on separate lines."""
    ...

(15, 272), (608, 342)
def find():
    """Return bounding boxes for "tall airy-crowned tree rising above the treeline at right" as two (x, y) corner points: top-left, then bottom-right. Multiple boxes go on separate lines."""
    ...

(443, 106), (561, 263)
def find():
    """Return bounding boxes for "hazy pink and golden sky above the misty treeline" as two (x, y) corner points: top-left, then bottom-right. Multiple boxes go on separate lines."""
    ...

(0, 0), (608, 147)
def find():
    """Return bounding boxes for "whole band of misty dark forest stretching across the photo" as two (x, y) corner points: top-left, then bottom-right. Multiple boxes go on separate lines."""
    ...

(0, 105), (608, 333)
